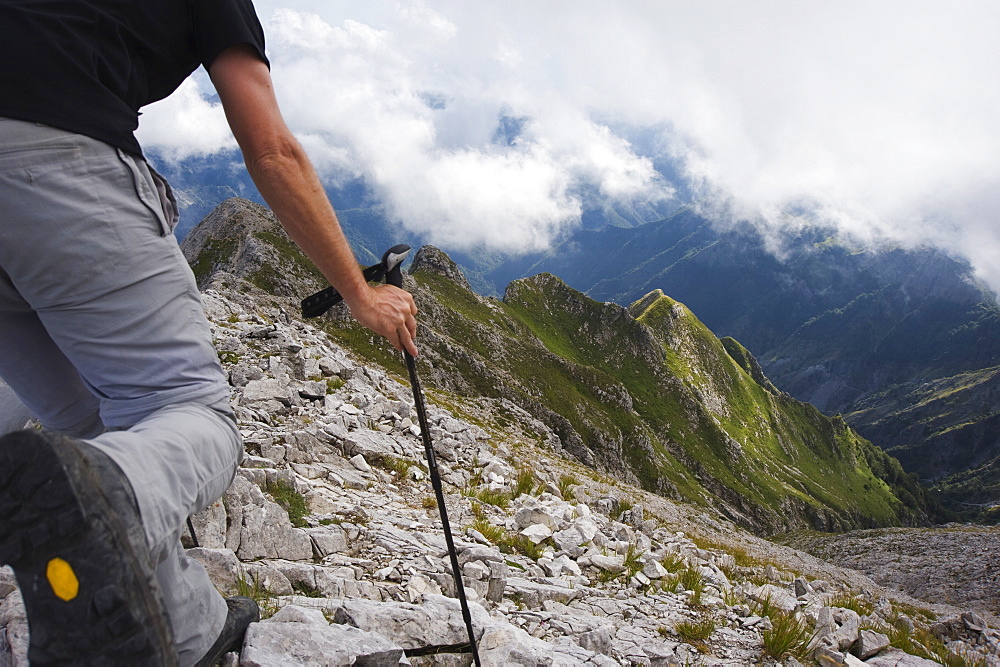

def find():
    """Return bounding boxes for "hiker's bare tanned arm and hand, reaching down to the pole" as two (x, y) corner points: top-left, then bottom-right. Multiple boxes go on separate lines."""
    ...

(209, 46), (417, 355)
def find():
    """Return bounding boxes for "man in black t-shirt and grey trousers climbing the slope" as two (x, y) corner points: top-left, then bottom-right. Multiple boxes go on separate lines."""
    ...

(0, 0), (416, 665)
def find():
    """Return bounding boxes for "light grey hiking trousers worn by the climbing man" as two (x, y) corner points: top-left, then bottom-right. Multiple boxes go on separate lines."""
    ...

(0, 118), (243, 664)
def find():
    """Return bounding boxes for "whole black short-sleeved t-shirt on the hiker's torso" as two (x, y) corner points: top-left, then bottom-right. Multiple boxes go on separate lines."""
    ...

(0, 0), (267, 155)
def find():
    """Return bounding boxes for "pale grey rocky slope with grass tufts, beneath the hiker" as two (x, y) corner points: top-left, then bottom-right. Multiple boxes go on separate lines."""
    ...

(0, 292), (1000, 667)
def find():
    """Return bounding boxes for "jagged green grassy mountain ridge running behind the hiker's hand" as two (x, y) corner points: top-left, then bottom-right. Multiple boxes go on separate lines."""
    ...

(183, 200), (928, 533)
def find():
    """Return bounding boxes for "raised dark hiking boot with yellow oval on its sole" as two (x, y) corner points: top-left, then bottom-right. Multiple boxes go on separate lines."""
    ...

(0, 430), (177, 666)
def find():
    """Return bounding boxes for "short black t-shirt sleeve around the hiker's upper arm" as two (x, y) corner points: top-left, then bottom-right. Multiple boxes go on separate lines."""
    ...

(193, 0), (270, 69)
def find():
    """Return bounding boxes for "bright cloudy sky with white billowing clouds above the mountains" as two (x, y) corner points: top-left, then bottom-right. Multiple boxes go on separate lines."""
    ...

(139, 0), (1000, 290)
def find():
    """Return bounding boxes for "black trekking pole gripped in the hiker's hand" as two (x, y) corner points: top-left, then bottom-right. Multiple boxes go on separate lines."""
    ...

(302, 244), (480, 667)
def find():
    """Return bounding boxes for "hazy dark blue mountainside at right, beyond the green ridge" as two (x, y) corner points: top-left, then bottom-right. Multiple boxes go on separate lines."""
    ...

(458, 211), (1000, 520)
